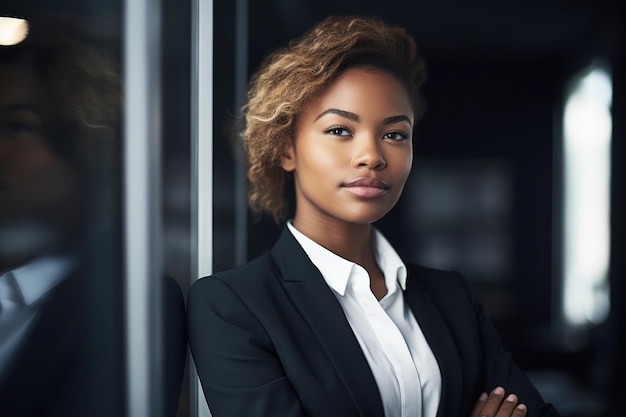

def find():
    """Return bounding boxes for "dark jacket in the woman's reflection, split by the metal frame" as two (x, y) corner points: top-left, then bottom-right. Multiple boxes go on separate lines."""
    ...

(0, 270), (187, 417)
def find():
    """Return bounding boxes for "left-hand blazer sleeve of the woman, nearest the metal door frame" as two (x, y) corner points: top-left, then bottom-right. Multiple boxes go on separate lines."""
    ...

(187, 277), (305, 417)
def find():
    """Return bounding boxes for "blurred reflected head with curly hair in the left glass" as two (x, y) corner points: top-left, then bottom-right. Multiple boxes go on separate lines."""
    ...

(0, 16), (121, 269)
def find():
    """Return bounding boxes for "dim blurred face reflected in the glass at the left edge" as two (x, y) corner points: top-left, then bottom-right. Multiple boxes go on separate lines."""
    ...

(0, 64), (77, 256)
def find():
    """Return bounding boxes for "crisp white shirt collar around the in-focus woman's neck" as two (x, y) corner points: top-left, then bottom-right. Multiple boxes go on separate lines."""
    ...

(287, 222), (407, 296)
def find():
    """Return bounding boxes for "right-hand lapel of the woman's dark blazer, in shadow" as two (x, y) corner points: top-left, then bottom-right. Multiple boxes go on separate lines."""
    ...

(405, 272), (463, 417)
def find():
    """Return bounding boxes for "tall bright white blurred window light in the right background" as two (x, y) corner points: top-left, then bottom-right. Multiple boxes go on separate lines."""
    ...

(563, 68), (612, 325)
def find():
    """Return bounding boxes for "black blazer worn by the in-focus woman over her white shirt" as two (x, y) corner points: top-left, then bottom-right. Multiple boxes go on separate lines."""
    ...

(188, 229), (557, 417)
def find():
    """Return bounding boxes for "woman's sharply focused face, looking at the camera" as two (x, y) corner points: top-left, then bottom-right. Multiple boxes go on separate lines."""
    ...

(282, 68), (414, 231)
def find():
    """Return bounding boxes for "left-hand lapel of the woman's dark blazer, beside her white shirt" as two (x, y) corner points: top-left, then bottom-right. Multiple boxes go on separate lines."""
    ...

(272, 228), (384, 417)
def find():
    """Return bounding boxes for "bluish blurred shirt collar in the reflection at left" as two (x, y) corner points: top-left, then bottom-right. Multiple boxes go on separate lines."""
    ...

(6, 256), (74, 305)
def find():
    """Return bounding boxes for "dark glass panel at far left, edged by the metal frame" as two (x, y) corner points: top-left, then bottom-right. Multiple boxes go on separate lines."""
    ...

(0, 1), (124, 417)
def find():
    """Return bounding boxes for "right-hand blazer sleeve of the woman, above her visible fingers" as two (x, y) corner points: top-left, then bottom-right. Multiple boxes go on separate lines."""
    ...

(459, 276), (558, 417)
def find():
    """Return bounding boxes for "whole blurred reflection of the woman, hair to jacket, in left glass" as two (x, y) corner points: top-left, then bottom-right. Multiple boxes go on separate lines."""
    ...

(0, 13), (121, 417)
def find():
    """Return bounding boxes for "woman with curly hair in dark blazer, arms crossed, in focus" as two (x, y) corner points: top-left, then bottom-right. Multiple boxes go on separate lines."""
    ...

(188, 18), (556, 417)
